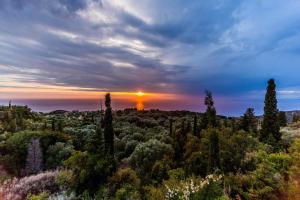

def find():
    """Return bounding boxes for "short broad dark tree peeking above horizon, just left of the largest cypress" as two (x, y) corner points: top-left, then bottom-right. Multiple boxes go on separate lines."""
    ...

(240, 108), (257, 133)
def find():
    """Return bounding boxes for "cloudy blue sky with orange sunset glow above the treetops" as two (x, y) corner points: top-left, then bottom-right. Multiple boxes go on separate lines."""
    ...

(0, 0), (300, 115)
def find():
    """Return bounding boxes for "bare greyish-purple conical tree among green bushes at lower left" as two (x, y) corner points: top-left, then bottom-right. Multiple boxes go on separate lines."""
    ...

(25, 138), (43, 174)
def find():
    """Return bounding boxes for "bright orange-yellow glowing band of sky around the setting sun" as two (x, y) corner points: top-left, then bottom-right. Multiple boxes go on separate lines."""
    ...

(0, 83), (180, 102)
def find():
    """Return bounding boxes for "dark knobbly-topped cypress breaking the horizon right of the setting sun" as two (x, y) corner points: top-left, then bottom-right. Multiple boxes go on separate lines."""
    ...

(202, 90), (217, 128)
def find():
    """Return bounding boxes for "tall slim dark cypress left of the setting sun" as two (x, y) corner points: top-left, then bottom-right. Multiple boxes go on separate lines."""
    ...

(104, 93), (114, 156)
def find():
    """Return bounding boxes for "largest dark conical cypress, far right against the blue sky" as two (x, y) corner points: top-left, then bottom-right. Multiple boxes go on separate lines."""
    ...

(260, 79), (281, 145)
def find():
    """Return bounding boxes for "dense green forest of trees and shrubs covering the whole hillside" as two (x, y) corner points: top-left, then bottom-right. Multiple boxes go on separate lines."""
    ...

(0, 80), (300, 200)
